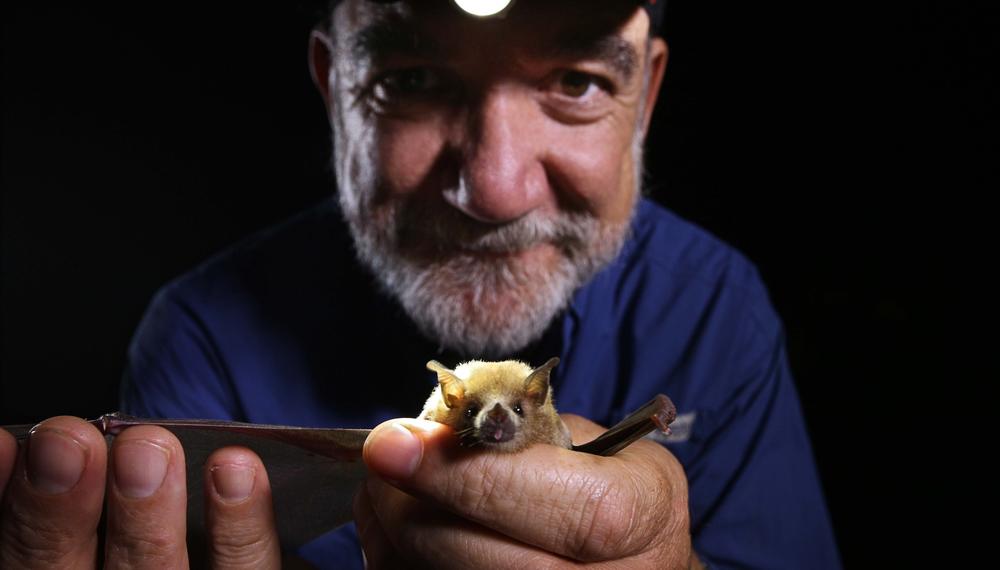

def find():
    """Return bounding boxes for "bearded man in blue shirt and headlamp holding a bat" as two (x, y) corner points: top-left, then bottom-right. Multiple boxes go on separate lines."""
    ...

(0, 0), (839, 568)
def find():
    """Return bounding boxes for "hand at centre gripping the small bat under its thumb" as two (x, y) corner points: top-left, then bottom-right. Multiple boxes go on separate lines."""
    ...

(354, 415), (699, 569)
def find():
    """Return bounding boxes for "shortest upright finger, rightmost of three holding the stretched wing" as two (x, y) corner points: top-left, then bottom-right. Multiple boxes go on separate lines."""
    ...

(204, 447), (281, 569)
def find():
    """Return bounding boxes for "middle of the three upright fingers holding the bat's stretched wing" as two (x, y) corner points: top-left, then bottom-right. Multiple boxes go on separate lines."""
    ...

(105, 425), (187, 568)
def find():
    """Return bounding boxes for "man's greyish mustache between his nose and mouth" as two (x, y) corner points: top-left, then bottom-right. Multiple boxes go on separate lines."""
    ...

(395, 204), (600, 253)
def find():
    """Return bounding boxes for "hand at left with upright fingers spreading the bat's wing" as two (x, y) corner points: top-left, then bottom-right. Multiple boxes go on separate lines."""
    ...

(0, 416), (280, 569)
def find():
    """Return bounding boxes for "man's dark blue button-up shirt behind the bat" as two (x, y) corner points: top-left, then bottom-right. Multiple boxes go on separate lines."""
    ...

(122, 200), (840, 569)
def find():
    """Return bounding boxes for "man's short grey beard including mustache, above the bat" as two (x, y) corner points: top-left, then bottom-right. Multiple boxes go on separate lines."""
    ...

(341, 193), (629, 357)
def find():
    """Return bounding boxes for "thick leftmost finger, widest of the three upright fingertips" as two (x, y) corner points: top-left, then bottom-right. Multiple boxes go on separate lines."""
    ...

(0, 416), (108, 568)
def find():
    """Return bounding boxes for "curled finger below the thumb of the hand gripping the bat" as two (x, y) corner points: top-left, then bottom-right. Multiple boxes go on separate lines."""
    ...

(359, 477), (566, 569)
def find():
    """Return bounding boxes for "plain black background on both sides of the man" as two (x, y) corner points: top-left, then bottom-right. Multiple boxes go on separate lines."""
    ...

(0, 0), (1000, 567)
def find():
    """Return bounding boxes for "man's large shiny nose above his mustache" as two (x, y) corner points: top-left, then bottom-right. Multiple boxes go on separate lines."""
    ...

(445, 90), (550, 223)
